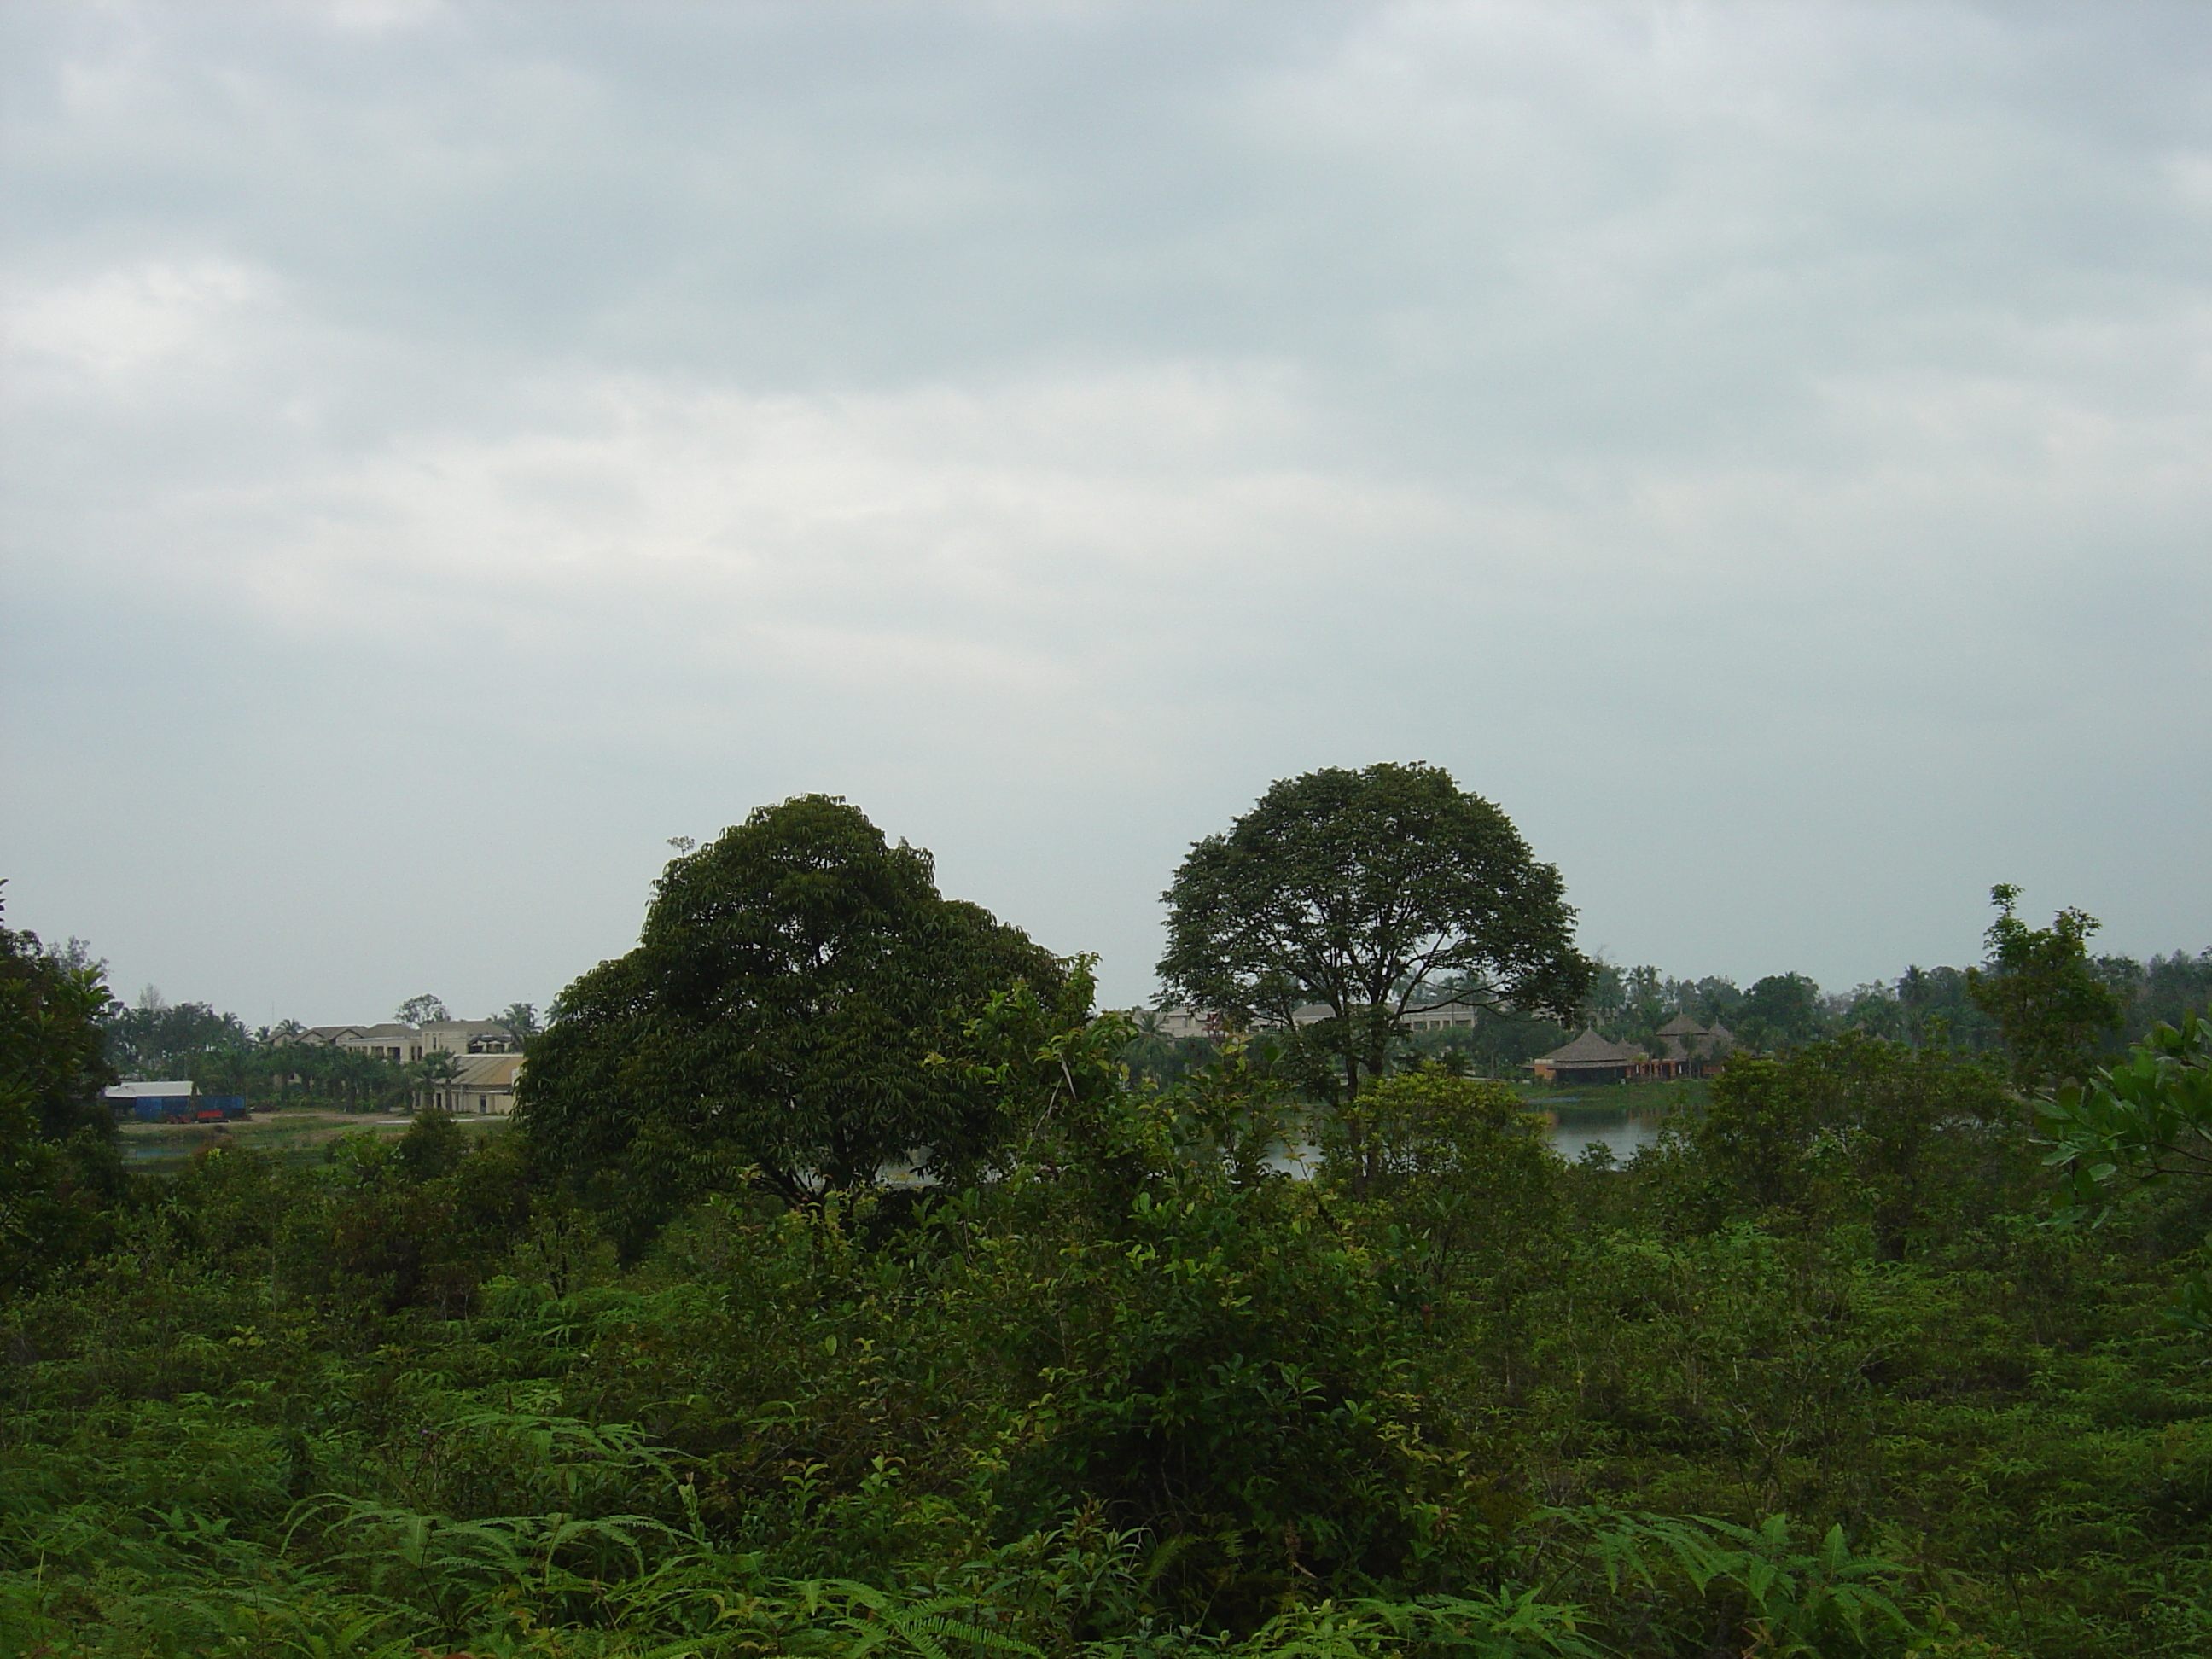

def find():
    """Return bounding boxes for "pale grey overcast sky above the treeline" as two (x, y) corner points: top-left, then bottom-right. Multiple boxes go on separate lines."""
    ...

(0, 0), (2212, 1024)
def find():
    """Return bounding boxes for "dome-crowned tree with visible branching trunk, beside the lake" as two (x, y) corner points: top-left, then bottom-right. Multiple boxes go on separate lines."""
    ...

(1159, 763), (1592, 1099)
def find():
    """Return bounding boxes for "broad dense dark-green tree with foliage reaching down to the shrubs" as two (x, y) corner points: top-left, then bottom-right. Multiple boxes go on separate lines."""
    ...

(520, 795), (1064, 1248)
